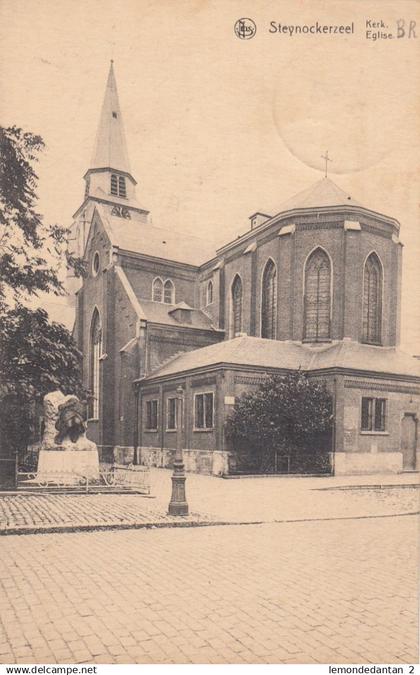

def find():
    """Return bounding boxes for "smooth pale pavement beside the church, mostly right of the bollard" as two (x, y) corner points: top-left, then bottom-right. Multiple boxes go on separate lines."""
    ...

(152, 469), (420, 522)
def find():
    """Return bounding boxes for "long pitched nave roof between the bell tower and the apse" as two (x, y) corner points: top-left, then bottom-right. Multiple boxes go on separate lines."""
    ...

(96, 204), (216, 267)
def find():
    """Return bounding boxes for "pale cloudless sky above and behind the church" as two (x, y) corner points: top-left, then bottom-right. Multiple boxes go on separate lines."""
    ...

(0, 0), (420, 354)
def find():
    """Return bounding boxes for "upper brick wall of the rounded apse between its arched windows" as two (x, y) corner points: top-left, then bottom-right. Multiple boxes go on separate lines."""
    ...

(213, 212), (401, 346)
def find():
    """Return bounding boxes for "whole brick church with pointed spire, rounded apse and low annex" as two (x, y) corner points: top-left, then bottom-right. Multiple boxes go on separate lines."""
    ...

(69, 63), (420, 475)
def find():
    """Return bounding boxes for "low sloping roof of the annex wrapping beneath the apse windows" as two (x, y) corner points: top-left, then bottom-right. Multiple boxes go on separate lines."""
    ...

(140, 336), (420, 380)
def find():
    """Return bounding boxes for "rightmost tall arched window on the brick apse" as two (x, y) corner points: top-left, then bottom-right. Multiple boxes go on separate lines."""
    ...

(362, 253), (382, 344)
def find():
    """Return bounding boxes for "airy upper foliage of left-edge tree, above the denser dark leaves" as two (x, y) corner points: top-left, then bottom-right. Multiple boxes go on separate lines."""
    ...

(0, 127), (84, 310)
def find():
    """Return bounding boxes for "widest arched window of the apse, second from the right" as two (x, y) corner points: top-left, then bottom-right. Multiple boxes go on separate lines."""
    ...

(303, 248), (331, 342)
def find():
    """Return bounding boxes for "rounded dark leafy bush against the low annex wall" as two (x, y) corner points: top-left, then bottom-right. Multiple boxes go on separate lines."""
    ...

(226, 371), (333, 471)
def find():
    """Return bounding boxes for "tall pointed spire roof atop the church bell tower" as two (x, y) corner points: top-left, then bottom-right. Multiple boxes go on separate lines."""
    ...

(90, 61), (131, 174)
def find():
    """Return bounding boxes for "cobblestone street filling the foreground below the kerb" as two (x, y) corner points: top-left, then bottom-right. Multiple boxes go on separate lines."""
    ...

(0, 516), (418, 663)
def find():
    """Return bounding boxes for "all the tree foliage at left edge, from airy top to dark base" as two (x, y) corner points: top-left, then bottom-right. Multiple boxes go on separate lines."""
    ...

(0, 127), (84, 464)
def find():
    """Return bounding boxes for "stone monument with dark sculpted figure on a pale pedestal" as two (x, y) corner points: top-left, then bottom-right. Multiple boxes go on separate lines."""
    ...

(37, 391), (99, 485)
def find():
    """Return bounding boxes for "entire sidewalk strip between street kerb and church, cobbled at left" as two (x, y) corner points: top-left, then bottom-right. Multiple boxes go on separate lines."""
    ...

(0, 469), (420, 534)
